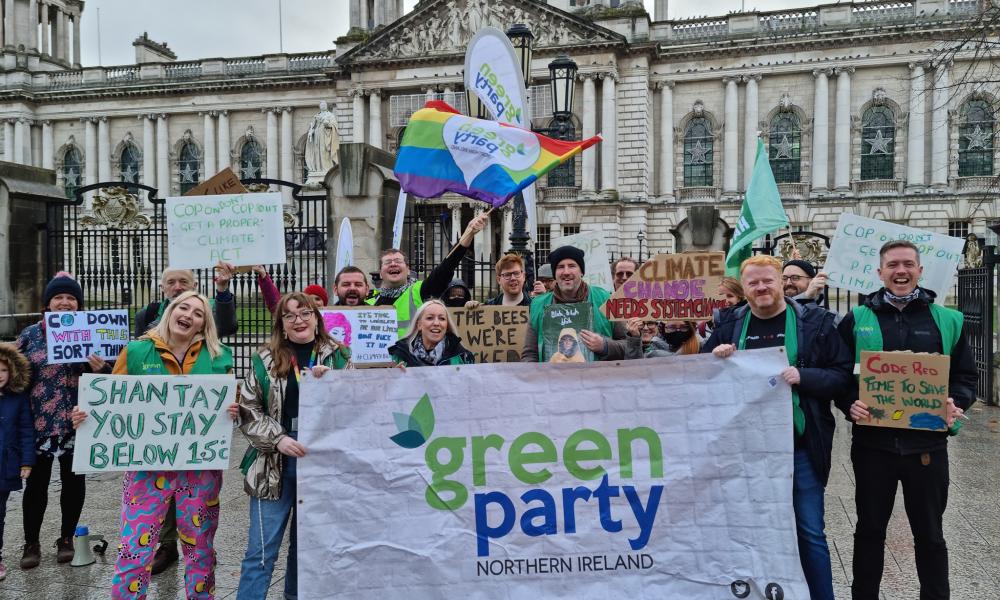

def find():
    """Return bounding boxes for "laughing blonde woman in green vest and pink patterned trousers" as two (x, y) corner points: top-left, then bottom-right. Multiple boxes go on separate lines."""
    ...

(73, 291), (236, 600)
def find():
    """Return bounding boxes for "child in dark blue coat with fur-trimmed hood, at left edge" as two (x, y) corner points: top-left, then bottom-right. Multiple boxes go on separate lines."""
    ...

(0, 344), (35, 580)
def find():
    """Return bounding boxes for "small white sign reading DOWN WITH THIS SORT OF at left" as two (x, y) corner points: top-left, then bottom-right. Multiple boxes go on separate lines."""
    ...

(45, 310), (129, 364)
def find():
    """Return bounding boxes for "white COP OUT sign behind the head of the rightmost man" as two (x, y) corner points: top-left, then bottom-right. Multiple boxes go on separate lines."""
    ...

(823, 213), (965, 297)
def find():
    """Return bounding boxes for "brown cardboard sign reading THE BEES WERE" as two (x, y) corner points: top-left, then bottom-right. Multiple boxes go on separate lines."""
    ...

(448, 306), (528, 363)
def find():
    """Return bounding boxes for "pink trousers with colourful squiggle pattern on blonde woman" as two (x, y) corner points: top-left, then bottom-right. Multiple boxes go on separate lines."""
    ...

(111, 471), (222, 600)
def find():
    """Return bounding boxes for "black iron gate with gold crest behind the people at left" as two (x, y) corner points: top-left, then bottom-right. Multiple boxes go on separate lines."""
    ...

(45, 179), (327, 376)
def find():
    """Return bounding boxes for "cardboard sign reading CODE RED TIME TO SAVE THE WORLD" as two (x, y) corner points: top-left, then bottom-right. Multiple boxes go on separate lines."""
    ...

(857, 351), (951, 431)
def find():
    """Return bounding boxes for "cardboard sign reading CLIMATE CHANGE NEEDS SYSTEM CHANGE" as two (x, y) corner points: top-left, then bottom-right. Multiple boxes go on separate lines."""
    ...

(603, 252), (727, 321)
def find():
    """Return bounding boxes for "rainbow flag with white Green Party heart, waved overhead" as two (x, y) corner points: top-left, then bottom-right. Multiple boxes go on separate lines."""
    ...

(395, 100), (601, 206)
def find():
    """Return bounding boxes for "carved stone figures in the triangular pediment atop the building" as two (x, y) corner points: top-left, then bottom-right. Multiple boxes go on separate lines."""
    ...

(354, 0), (618, 61)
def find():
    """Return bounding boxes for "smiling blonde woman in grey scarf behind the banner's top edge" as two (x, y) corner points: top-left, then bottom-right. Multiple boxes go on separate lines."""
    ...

(389, 300), (476, 367)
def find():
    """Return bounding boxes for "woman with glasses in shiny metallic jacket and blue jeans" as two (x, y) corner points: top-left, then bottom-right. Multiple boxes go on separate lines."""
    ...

(236, 292), (351, 600)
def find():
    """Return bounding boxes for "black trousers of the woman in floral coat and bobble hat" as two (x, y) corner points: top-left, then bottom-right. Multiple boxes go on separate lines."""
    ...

(23, 452), (87, 544)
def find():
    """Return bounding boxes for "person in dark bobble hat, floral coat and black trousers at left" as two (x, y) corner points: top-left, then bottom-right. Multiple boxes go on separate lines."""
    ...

(17, 271), (111, 569)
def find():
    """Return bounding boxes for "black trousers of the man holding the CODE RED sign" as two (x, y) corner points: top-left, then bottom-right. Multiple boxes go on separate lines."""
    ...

(851, 446), (950, 600)
